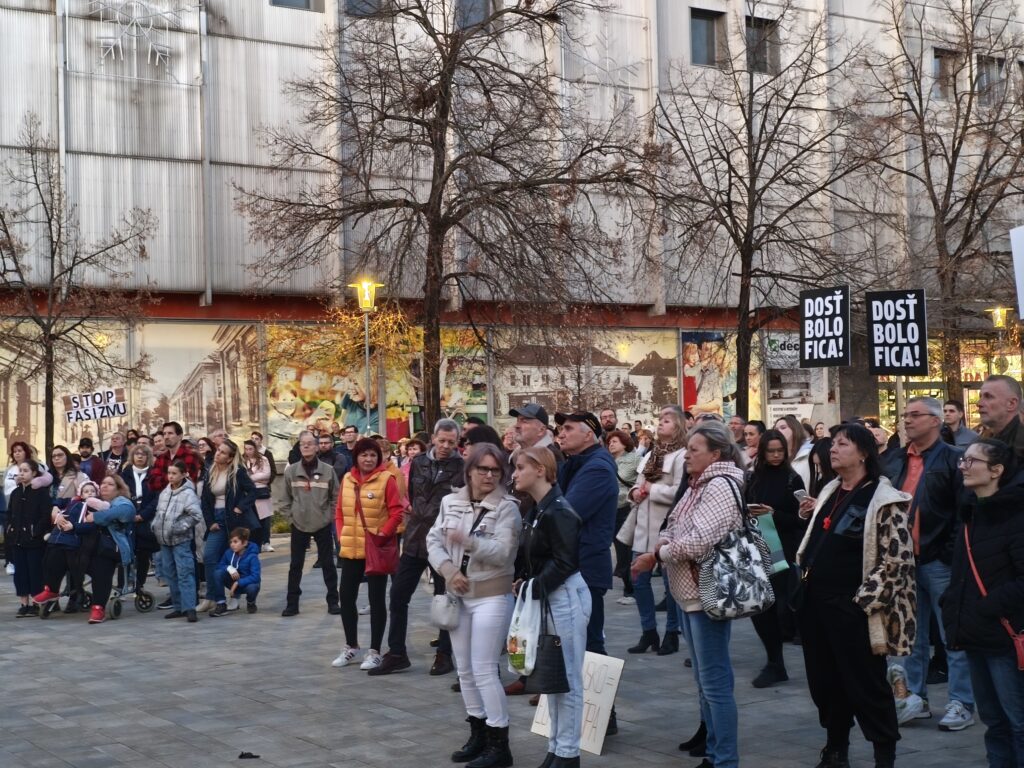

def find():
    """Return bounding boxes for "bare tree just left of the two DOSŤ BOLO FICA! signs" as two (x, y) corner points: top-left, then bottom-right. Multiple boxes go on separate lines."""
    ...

(657, 0), (873, 418)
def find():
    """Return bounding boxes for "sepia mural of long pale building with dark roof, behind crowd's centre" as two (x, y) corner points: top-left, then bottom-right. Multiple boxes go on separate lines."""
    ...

(495, 329), (679, 426)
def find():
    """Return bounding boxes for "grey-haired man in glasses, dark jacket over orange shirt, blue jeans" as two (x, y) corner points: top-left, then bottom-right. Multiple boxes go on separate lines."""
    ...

(885, 397), (974, 731)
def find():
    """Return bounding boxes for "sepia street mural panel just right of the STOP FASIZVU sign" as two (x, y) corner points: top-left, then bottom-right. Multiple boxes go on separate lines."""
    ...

(136, 323), (263, 440)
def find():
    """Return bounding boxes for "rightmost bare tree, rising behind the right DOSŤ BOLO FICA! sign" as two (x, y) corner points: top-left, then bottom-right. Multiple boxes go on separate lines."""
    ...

(867, 0), (1024, 398)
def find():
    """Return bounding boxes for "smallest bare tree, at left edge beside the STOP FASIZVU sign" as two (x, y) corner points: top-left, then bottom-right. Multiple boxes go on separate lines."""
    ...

(0, 115), (156, 456)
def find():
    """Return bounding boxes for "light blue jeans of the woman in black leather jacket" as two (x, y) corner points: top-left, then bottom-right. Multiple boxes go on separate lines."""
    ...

(548, 571), (591, 758)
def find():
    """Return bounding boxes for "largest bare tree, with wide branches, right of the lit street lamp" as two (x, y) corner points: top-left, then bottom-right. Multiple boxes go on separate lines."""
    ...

(239, 0), (649, 423)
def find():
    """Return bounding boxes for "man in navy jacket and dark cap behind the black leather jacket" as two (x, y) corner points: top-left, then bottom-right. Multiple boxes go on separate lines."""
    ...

(555, 411), (618, 734)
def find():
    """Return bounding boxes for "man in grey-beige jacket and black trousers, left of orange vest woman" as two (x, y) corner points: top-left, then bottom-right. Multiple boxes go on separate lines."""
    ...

(278, 431), (341, 616)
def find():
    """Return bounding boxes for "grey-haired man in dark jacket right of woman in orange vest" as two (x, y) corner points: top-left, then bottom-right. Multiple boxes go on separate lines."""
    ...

(368, 419), (465, 676)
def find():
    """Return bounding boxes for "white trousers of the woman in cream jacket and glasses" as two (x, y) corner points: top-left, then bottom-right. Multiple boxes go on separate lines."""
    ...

(452, 594), (515, 728)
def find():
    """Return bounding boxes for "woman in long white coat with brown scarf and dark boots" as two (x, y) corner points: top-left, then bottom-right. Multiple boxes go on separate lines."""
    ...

(618, 407), (686, 655)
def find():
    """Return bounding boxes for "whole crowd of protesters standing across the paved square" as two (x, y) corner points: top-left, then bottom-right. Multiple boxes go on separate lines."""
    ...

(4, 376), (1024, 768)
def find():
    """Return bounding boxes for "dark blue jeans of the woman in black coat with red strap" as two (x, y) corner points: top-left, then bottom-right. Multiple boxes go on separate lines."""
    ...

(967, 650), (1024, 768)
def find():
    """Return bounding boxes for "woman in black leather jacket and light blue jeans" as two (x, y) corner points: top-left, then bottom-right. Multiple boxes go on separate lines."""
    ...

(515, 446), (591, 768)
